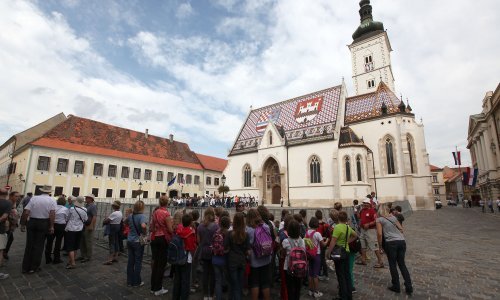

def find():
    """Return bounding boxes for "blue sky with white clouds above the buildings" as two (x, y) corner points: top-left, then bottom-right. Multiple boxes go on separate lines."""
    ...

(0, 0), (500, 166)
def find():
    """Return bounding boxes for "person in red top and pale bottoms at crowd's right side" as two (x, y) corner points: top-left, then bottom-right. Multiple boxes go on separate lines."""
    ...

(357, 198), (384, 268)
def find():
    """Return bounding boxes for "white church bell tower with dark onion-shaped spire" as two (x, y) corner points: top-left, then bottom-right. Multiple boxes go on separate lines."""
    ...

(348, 0), (396, 95)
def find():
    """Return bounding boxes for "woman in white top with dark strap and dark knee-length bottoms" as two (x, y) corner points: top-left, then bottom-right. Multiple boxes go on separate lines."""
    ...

(64, 196), (87, 269)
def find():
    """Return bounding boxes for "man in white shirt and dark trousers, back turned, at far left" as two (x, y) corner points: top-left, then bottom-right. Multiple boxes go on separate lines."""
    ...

(21, 185), (57, 274)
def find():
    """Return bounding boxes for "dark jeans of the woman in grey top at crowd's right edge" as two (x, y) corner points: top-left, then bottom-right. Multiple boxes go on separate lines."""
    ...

(385, 241), (413, 292)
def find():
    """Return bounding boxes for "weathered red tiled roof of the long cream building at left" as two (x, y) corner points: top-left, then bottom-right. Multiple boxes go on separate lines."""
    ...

(32, 116), (203, 170)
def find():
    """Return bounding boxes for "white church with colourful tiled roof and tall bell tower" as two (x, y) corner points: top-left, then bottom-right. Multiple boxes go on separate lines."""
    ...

(224, 0), (434, 209)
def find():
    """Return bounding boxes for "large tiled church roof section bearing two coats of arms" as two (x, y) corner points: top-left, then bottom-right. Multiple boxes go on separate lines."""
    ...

(230, 85), (342, 154)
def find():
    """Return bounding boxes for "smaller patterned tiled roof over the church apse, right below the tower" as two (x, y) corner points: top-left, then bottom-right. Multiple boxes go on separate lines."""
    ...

(345, 81), (409, 124)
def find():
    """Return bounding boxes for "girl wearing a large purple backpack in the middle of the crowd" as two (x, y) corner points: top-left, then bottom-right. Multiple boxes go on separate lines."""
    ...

(246, 208), (272, 300)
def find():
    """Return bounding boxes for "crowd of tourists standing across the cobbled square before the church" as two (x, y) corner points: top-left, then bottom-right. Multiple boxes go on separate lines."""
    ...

(0, 186), (413, 300)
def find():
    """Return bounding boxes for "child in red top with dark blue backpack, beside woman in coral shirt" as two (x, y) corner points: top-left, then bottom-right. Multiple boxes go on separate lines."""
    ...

(172, 214), (196, 300)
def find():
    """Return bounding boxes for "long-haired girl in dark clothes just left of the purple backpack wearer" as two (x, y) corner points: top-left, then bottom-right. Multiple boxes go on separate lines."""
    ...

(224, 212), (250, 300)
